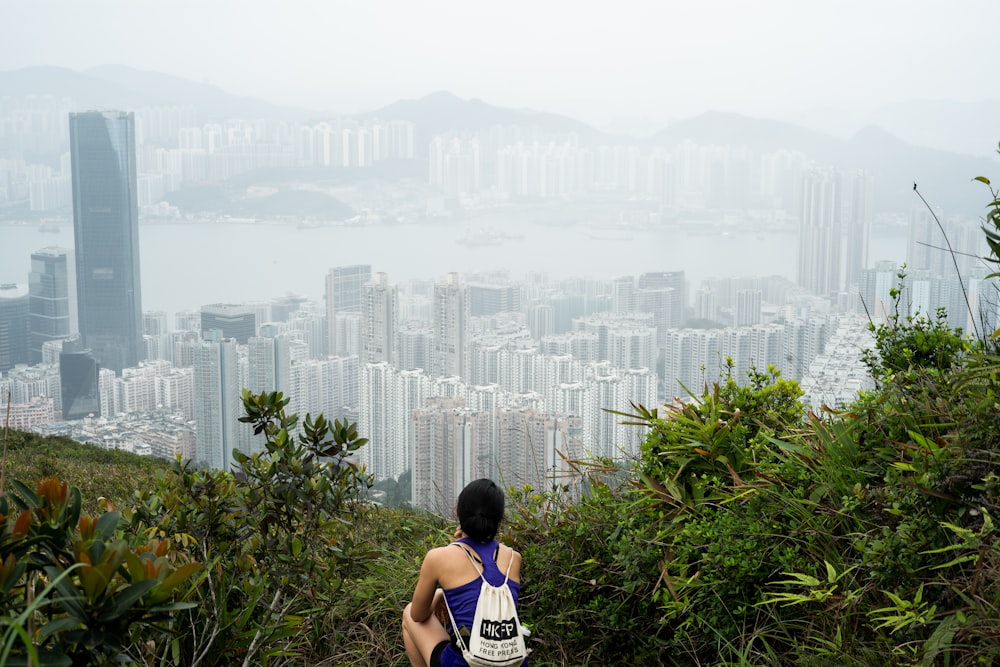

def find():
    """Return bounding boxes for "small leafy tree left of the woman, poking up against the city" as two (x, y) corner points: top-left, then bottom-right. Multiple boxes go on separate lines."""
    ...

(132, 390), (372, 665)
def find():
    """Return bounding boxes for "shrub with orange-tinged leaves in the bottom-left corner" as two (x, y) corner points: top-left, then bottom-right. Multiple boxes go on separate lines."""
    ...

(0, 477), (200, 665)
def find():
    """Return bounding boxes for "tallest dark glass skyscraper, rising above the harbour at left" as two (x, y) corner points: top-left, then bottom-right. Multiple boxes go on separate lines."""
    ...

(69, 111), (143, 374)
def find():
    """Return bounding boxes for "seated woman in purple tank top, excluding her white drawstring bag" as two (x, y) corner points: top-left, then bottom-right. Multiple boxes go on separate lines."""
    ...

(403, 479), (521, 667)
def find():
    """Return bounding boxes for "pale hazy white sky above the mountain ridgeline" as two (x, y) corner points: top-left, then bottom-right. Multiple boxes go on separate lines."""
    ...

(0, 0), (1000, 124)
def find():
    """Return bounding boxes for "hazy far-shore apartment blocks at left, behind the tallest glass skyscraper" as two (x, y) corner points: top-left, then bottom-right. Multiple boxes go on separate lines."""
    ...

(0, 98), (417, 212)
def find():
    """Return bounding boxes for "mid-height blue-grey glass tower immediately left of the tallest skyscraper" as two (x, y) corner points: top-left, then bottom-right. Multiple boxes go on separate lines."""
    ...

(28, 248), (71, 364)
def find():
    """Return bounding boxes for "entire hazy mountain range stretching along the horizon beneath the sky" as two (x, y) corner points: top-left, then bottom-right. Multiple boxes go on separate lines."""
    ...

(0, 65), (1000, 215)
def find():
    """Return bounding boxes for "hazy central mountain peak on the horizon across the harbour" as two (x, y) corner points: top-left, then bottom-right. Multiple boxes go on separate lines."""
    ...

(357, 91), (609, 145)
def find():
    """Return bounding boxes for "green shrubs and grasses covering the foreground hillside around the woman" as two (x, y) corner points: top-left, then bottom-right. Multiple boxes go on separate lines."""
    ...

(0, 171), (1000, 667)
